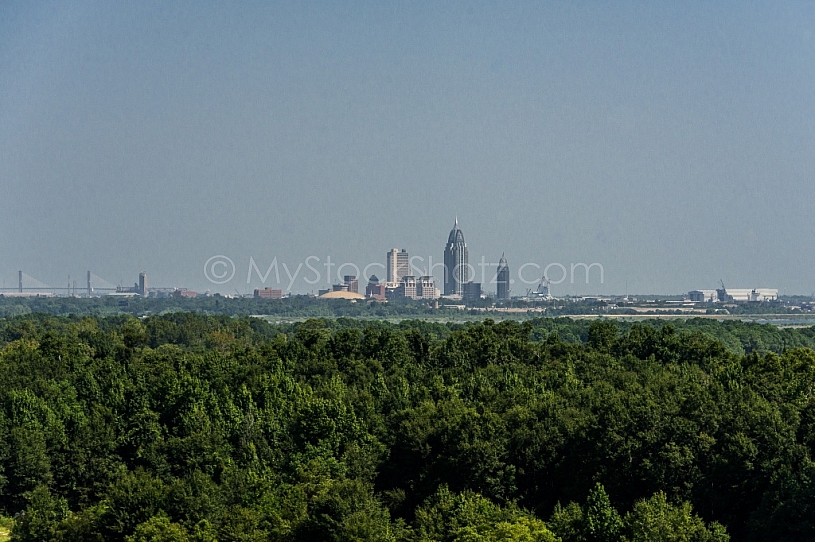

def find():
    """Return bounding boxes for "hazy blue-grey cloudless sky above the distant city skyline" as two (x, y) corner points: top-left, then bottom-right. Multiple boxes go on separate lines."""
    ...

(0, 0), (815, 295)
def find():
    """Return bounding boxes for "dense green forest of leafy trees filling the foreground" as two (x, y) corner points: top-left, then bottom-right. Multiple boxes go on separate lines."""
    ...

(0, 312), (815, 542)
